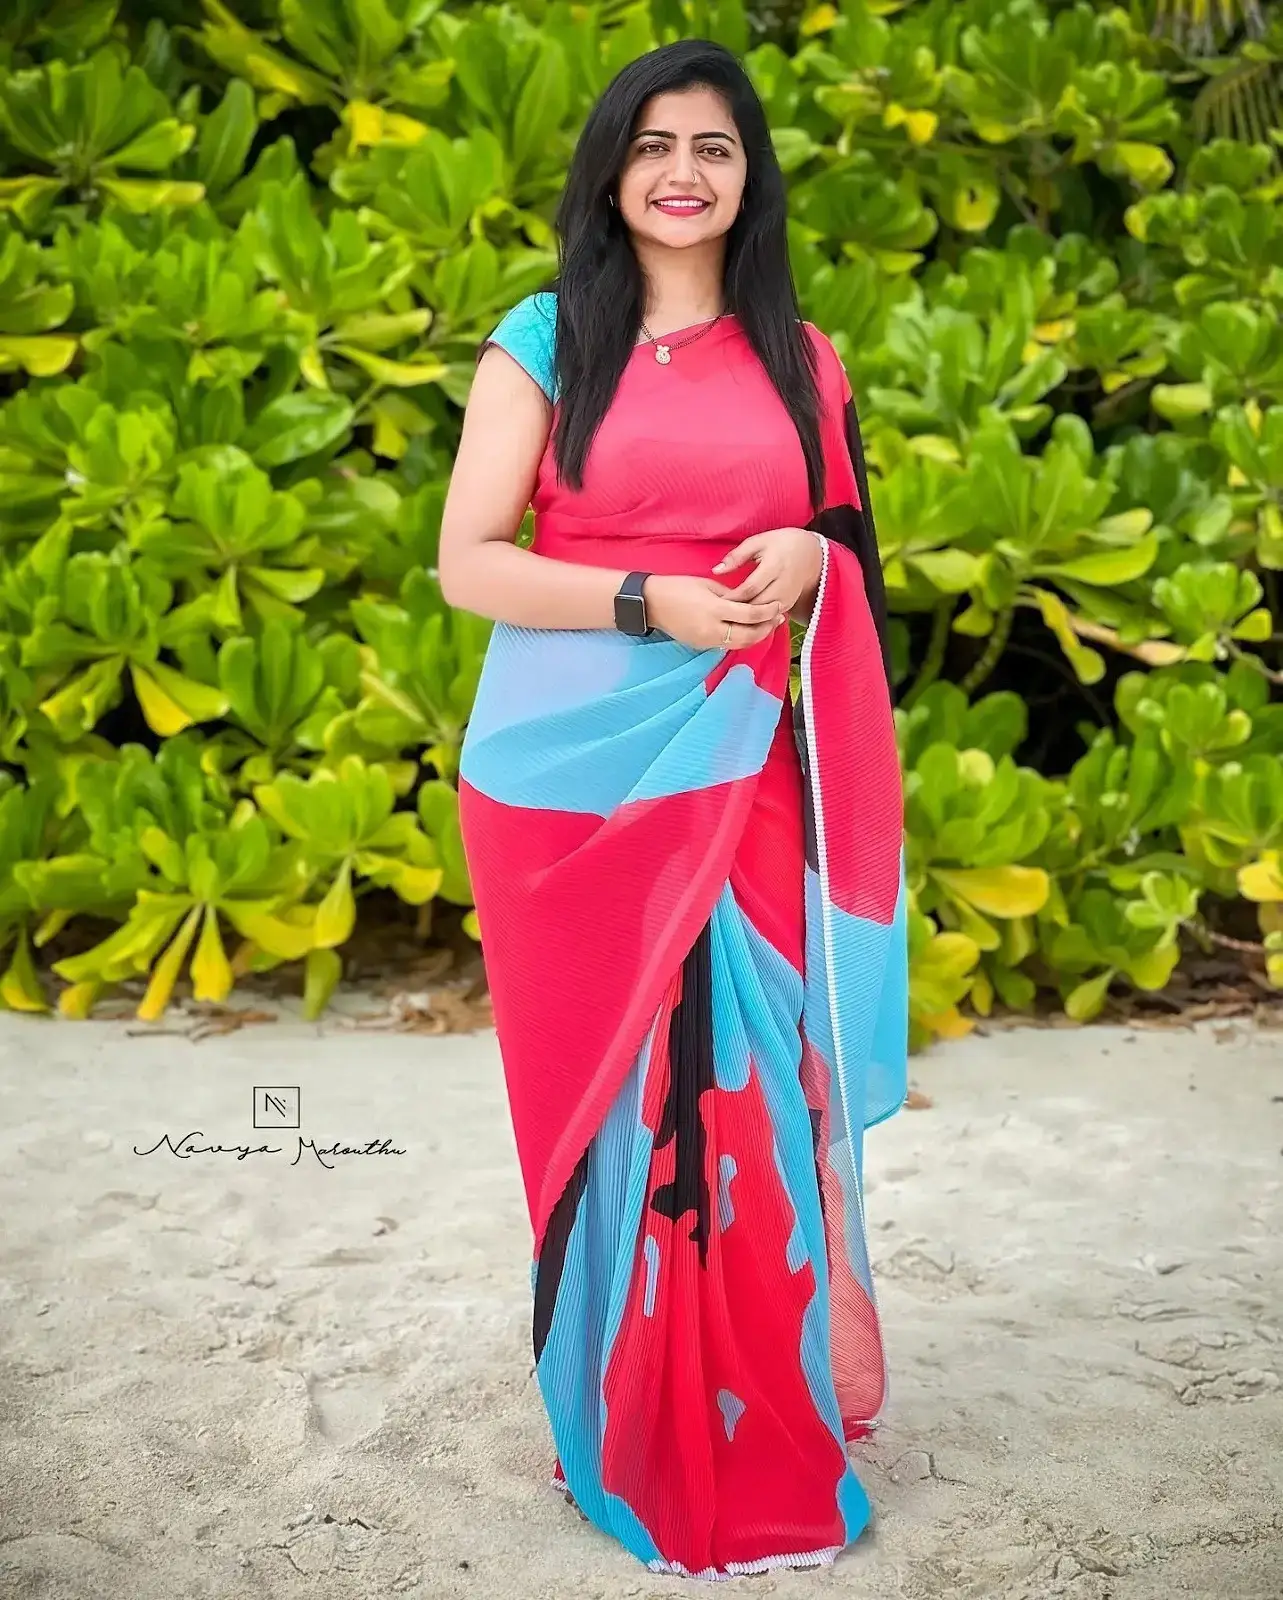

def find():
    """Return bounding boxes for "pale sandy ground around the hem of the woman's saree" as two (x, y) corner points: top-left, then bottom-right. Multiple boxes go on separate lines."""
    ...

(0, 1016), (1283, 1600)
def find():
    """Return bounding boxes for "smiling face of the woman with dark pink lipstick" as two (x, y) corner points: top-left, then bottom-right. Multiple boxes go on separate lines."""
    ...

(616, 88), (749, 250)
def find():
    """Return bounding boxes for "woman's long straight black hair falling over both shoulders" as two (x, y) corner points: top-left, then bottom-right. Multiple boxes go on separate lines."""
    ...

(537, 38), (824, 510)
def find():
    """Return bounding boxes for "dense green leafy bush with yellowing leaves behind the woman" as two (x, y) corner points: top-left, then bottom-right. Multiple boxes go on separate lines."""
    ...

(0, 0), (1283, 1043)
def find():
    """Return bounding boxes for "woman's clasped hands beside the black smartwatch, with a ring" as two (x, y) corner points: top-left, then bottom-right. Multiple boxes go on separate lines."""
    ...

(645, 528), (822, 650)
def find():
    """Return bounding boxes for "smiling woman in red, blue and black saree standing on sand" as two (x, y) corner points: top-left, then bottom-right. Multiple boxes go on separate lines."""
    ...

(440, 40), (905, 1578)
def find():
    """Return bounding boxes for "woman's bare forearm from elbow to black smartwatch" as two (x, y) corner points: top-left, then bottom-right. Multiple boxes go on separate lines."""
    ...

(440, 539), (627, 629)
